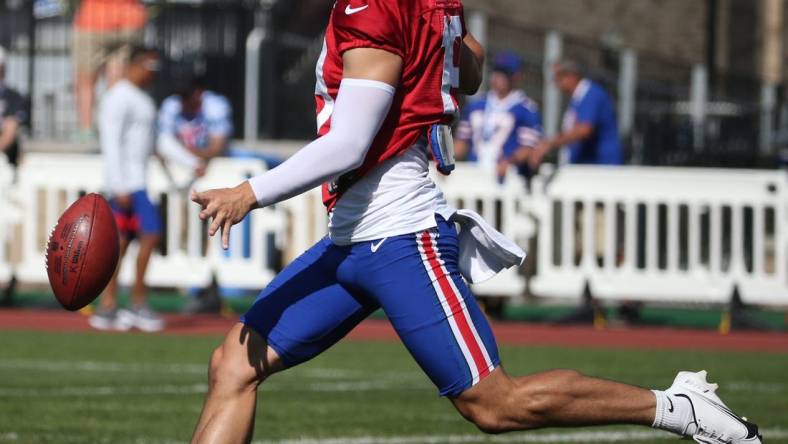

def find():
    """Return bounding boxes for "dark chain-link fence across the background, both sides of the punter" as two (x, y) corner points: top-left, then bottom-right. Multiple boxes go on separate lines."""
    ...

(0, 0), (786, 167)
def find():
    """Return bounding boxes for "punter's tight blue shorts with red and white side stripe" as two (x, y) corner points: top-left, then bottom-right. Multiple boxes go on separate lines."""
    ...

(241, 216), (500, 396)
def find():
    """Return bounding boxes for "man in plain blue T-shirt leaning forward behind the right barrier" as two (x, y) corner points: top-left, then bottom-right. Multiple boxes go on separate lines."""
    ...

(523, 59), (624, 169)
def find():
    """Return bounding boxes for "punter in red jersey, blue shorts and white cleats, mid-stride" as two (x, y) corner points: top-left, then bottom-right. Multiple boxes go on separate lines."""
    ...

(192, 0), (760, 443)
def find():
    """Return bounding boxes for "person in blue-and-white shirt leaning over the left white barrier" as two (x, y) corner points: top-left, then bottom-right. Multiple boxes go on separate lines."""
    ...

(157, 76), (233, 166)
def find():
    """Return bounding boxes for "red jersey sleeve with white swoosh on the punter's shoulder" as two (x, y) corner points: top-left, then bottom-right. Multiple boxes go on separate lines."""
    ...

(331, 0), (406, 59)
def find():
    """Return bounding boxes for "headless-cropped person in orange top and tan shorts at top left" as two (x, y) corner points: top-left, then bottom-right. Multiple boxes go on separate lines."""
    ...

(74, 0), (147, 142)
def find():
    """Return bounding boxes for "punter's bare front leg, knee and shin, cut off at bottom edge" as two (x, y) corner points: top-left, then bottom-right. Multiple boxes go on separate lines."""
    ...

(192, 323), (282, 444)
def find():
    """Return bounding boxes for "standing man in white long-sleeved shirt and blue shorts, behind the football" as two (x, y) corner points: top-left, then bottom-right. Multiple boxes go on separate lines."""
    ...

(90, 48), (202, 331)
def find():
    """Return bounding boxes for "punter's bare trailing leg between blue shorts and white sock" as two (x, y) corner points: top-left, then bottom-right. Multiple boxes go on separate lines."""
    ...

(452, 368), (656, 433)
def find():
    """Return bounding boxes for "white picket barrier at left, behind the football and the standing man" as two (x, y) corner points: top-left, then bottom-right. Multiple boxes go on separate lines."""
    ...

(6, 154), (283, 288)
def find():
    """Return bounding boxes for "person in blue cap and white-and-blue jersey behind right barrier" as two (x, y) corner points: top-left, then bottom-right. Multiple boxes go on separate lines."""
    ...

(454, 52), (542, 182)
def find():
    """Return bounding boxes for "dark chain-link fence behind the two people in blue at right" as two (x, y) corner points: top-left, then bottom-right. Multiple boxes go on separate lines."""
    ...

(488, 13), (772, 168)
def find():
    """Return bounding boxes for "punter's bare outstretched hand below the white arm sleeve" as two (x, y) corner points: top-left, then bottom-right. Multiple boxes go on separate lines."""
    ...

(191, 181), (257, 250)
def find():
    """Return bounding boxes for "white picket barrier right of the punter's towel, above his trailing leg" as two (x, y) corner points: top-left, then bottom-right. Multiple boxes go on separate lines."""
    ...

(530, 166), (788, 305)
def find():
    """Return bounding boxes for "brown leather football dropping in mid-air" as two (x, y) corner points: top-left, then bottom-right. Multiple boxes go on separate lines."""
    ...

(46, 194), (120, 310)
